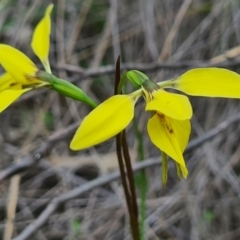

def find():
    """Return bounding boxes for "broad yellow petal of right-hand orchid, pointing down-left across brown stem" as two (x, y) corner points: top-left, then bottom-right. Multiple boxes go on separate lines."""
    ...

(70, 95), (135, 150)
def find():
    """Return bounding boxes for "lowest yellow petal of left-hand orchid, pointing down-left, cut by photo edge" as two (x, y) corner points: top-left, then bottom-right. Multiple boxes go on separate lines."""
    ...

(0, 88), (31, 113)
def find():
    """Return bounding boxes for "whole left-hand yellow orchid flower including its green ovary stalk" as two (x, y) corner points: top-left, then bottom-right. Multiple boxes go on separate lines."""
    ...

(0, 4), (97, 112)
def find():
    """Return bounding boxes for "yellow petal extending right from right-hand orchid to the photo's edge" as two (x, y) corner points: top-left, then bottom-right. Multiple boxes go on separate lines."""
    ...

(172, 68), (240, 98)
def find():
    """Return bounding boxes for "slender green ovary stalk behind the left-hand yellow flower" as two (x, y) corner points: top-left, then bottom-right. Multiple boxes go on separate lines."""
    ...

(36, 71), (97, 108)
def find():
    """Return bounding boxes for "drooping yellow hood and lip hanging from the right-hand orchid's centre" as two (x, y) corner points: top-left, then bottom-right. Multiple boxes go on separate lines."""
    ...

(143, 88), (192, 178)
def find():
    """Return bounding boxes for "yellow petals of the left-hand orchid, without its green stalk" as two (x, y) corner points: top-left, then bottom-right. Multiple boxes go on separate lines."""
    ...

(0, 4), (53, 112)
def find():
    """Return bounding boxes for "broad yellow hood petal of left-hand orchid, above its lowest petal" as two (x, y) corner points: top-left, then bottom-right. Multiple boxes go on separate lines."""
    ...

(0, 44), (41, 85)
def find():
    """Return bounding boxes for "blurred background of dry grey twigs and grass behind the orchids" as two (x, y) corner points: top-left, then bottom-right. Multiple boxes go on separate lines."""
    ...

(0, 0), (240, 240)
